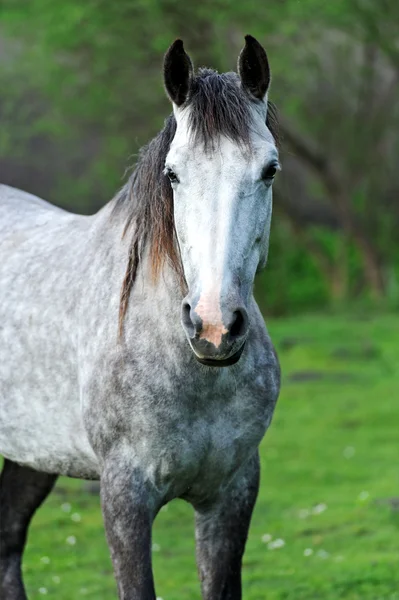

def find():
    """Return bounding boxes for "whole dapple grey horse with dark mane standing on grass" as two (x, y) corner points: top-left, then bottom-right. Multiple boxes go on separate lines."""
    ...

(0, 36), (280, 600)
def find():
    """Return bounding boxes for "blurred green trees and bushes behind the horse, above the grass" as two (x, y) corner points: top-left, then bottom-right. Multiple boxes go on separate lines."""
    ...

(0, 0), (399, 314)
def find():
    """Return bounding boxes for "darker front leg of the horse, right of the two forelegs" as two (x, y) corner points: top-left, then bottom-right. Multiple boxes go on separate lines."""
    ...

(196, 455), (259, 600)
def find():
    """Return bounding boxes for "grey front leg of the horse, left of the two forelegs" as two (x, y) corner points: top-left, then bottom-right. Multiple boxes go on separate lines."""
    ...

(101, 460), (156, 600)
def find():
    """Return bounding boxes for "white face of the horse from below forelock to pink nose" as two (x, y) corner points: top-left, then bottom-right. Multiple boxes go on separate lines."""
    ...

(166, 104), (277, 347)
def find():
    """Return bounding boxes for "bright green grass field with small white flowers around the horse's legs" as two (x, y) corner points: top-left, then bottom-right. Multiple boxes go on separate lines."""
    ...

(20, 315), (399, 600)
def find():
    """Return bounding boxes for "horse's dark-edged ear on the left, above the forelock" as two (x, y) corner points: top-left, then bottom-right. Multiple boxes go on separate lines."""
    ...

(163, 40), (193, 106)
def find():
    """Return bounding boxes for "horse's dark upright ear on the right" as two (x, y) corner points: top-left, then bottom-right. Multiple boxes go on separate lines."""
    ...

(238, 35), (270, 100)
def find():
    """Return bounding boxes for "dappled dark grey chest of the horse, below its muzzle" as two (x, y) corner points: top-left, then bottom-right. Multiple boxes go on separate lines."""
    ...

(84, 342), (278, 500)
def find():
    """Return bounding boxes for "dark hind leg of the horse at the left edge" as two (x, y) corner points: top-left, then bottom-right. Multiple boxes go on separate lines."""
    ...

(0, 459), (57, 600)
